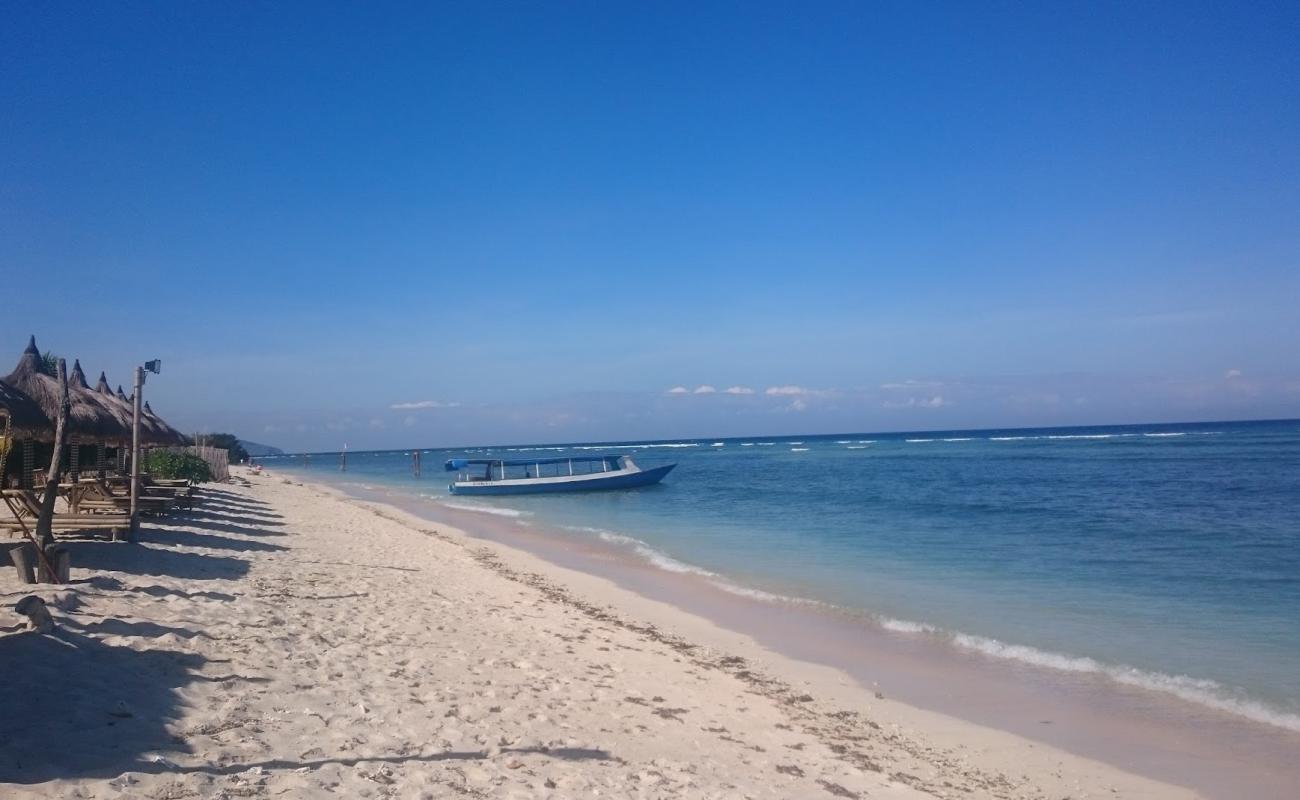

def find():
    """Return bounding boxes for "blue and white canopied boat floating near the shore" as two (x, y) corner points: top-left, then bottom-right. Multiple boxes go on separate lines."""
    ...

(447, 455), (677, 494)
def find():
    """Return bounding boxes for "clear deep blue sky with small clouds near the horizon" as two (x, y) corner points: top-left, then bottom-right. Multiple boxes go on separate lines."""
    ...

(0, 1), (1300, 450)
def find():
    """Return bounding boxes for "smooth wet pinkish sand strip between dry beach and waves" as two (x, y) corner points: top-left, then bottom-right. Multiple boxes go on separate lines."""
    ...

(309, 470), (1300, 797)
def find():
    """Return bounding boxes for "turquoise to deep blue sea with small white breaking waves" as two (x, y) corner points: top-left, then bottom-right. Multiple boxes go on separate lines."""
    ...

(263, 421), (1300, 730)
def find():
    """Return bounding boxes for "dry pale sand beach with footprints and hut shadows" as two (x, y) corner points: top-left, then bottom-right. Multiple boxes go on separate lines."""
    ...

(0, 471), (1195, 800)
